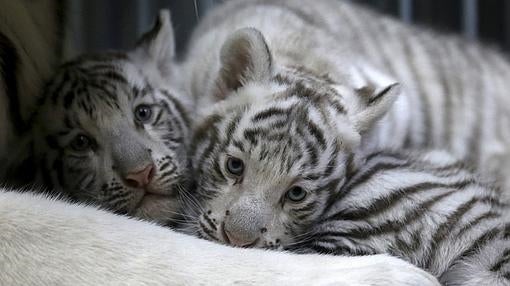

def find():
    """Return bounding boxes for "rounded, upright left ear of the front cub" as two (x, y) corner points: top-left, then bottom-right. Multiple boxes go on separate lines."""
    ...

(215, 28), (272, 100)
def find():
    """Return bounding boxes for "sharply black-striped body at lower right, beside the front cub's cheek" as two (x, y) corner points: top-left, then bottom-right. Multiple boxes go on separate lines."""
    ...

(298, 151), (510, 285)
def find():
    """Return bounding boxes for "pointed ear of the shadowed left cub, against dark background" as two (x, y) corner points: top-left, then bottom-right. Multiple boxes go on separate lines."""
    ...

(135, 9), (175, 75)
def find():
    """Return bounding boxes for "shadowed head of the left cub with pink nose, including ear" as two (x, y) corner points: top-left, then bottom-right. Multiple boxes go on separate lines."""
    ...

(34, 11), (191, 220)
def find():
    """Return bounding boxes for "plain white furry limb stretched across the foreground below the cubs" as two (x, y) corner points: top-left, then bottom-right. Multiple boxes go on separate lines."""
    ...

(0, 189), (439, 286)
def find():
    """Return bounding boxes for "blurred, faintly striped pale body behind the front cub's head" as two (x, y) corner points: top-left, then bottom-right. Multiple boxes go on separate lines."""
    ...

(188, 0), (510, 201)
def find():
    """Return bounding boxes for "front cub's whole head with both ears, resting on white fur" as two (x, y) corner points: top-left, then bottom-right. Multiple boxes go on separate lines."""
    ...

(189, 28), (399, 248)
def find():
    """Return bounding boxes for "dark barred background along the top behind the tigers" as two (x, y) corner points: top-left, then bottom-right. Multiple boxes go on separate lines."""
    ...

(66, 0), (510, 57)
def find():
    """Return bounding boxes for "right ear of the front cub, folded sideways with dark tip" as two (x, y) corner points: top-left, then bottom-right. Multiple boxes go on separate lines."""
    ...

(351, 61), (401, 133)
